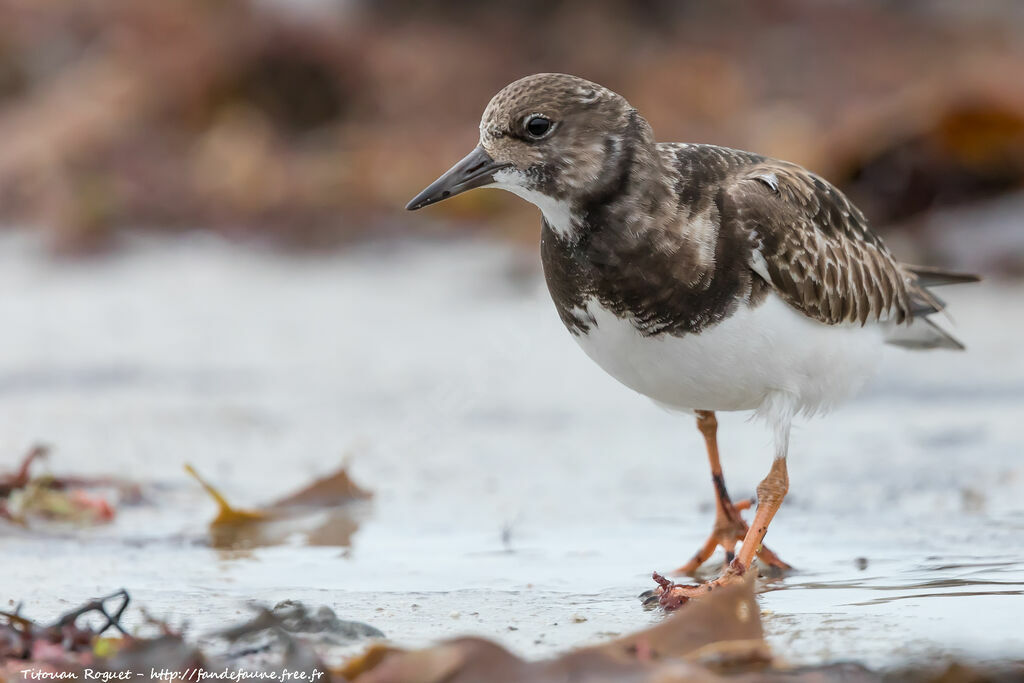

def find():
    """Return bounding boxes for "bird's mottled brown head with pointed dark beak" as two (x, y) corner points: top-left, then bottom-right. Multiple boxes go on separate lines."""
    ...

(406, 74), (651, 232)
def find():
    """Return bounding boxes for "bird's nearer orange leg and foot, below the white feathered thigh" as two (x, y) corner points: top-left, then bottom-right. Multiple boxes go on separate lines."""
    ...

(654, 458), (790, 609)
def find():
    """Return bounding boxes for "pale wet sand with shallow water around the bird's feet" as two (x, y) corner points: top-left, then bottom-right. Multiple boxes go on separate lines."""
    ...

(0, 232), (1024, 667)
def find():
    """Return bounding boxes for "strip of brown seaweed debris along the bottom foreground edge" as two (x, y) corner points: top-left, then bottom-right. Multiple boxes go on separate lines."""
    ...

(0, 581), (1024, 683)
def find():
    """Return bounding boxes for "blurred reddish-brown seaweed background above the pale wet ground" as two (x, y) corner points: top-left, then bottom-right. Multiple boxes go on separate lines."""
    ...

(0, 0), (1024, 272)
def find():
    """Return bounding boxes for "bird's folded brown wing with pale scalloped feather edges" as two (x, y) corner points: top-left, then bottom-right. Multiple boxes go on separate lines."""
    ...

(720, 161), (921, 325)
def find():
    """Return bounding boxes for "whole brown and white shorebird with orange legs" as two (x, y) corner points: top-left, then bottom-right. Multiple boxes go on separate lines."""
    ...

(406, 74), (978, 608)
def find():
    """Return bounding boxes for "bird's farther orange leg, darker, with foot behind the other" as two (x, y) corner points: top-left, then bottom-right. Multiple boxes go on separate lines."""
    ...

(673, 411), (791, 577)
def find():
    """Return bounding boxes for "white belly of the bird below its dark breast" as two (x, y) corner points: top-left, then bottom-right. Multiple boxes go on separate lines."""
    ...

(574, 294), (884, 413)
